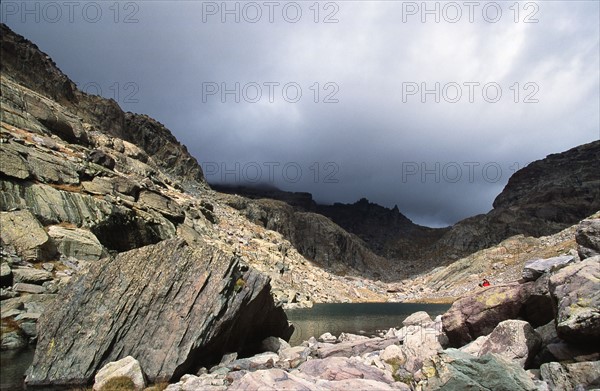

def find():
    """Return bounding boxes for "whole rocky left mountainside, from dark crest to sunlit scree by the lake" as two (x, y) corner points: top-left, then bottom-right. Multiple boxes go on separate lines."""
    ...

(0, 25), (386, 312)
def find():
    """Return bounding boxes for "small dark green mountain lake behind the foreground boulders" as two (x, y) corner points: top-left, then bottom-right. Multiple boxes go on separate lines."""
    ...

(286, 303), (450, 346)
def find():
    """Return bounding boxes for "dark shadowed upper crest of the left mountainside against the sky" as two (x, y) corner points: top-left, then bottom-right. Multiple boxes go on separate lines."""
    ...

(0, 24), (207, 191)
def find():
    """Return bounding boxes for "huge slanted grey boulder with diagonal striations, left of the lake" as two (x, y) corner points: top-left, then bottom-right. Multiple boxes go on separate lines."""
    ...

(26, 239), (293, 386)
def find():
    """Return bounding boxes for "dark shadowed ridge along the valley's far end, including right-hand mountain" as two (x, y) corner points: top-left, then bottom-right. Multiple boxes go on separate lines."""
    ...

(213, 136), (600, 272)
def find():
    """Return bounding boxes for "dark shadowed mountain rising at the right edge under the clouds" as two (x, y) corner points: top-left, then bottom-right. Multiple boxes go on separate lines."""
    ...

(436, 141), (600, 255)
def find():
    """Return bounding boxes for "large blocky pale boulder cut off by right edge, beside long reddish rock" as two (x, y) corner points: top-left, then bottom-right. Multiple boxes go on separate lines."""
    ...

(549, 256), (600, 343)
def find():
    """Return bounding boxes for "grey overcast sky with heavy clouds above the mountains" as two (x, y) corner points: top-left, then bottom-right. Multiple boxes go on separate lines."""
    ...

(1, 1), (600, 226)
